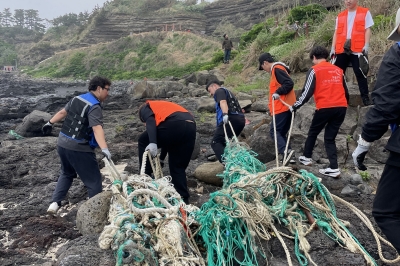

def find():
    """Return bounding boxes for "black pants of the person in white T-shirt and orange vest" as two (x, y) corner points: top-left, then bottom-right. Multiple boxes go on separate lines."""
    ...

(335, 53), (368, 99)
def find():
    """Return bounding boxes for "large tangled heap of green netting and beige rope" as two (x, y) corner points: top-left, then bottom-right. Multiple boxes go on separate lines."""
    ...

(196, 121), (393, 266)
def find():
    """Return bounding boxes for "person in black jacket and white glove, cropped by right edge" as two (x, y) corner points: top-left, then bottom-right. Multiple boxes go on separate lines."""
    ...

(352, 9), (400, 253)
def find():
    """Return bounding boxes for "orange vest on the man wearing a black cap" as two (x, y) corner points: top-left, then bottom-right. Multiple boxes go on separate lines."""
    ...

(268, 63), (296, 115)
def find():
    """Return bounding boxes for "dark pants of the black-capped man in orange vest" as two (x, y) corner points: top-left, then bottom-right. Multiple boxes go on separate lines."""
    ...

(269, 111), (292, 154)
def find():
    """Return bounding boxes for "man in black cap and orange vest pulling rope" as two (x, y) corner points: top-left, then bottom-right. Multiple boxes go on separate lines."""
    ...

(258, 53), (296, 163)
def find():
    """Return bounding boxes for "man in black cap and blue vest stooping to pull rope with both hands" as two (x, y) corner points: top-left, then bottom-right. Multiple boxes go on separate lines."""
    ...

(206, 80), (246, 163)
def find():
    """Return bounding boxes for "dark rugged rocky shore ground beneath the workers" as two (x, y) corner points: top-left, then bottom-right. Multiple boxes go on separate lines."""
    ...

(0, 71), (395, 266)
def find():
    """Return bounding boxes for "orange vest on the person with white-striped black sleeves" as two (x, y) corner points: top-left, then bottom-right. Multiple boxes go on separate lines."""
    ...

(312, 62), (347, 109)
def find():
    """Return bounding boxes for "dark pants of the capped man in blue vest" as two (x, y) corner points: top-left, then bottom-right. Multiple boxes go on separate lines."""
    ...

(211, 115), (246, 163)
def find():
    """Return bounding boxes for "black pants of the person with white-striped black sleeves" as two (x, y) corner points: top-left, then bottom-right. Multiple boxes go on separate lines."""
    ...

(303, 107), (347, 169)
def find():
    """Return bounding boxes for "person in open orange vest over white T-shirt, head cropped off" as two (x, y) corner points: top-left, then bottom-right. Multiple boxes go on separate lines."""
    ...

(330, 0), (374, 106)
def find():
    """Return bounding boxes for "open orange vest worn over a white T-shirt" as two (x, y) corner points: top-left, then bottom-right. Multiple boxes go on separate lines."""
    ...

(335, 6), (368, 54)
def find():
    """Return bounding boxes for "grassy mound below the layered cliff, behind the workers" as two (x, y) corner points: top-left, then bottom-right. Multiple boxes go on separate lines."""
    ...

(28, 32), (220, 79)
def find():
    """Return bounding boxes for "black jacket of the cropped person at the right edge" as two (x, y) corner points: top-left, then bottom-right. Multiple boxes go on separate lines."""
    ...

(361, 43), (400, 153)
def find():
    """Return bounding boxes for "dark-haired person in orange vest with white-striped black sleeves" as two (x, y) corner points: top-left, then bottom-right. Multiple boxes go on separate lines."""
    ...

(290, 46), (349, 178)
